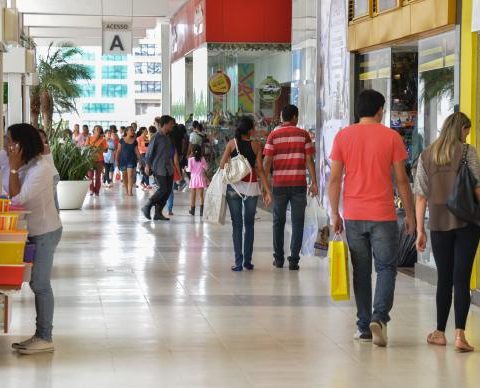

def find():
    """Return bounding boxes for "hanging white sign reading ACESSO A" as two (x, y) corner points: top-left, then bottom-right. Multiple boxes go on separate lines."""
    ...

(102, 22), (133, 55)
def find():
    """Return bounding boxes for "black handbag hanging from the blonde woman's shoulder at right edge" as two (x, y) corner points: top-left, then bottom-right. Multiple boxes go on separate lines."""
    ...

(447, 144), (480, 226)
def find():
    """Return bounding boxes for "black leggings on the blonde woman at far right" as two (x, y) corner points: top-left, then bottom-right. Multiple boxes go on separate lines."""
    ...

(430, 225), (480, 331)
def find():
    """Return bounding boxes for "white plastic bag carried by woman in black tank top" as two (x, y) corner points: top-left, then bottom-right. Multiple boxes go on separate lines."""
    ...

(203, 169), (227, 225)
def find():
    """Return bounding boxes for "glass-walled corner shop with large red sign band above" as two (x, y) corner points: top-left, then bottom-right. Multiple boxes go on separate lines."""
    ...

(171, 0), (292, 152)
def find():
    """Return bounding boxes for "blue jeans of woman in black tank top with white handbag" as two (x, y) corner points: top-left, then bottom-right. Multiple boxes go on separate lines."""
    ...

(227, 185), (258, 267)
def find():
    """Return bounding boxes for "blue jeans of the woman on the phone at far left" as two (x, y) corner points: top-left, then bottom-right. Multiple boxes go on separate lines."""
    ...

(29, 228), (62, 341)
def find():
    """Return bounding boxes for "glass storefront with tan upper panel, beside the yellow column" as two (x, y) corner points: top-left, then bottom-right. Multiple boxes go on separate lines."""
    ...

(348, 0), (460, 276)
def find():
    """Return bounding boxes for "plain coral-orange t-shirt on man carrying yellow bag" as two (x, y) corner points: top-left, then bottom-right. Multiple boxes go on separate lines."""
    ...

(330, 124), (408, 221)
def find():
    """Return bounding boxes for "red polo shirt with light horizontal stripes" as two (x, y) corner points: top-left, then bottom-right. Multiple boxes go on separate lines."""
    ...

(263, 126), (315, 187)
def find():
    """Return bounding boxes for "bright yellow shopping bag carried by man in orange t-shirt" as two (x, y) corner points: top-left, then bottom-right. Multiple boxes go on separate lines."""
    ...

(328, 234), (350, 301)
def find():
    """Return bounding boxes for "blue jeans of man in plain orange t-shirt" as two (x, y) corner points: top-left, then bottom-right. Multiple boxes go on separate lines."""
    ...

(345, 221), (399, 332)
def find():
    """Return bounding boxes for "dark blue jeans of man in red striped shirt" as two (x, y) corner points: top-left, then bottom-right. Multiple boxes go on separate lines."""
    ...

(273, 187), (307, 263)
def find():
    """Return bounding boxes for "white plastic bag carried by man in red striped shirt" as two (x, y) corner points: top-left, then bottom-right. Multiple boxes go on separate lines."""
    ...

(300, 196), (328, 257)
